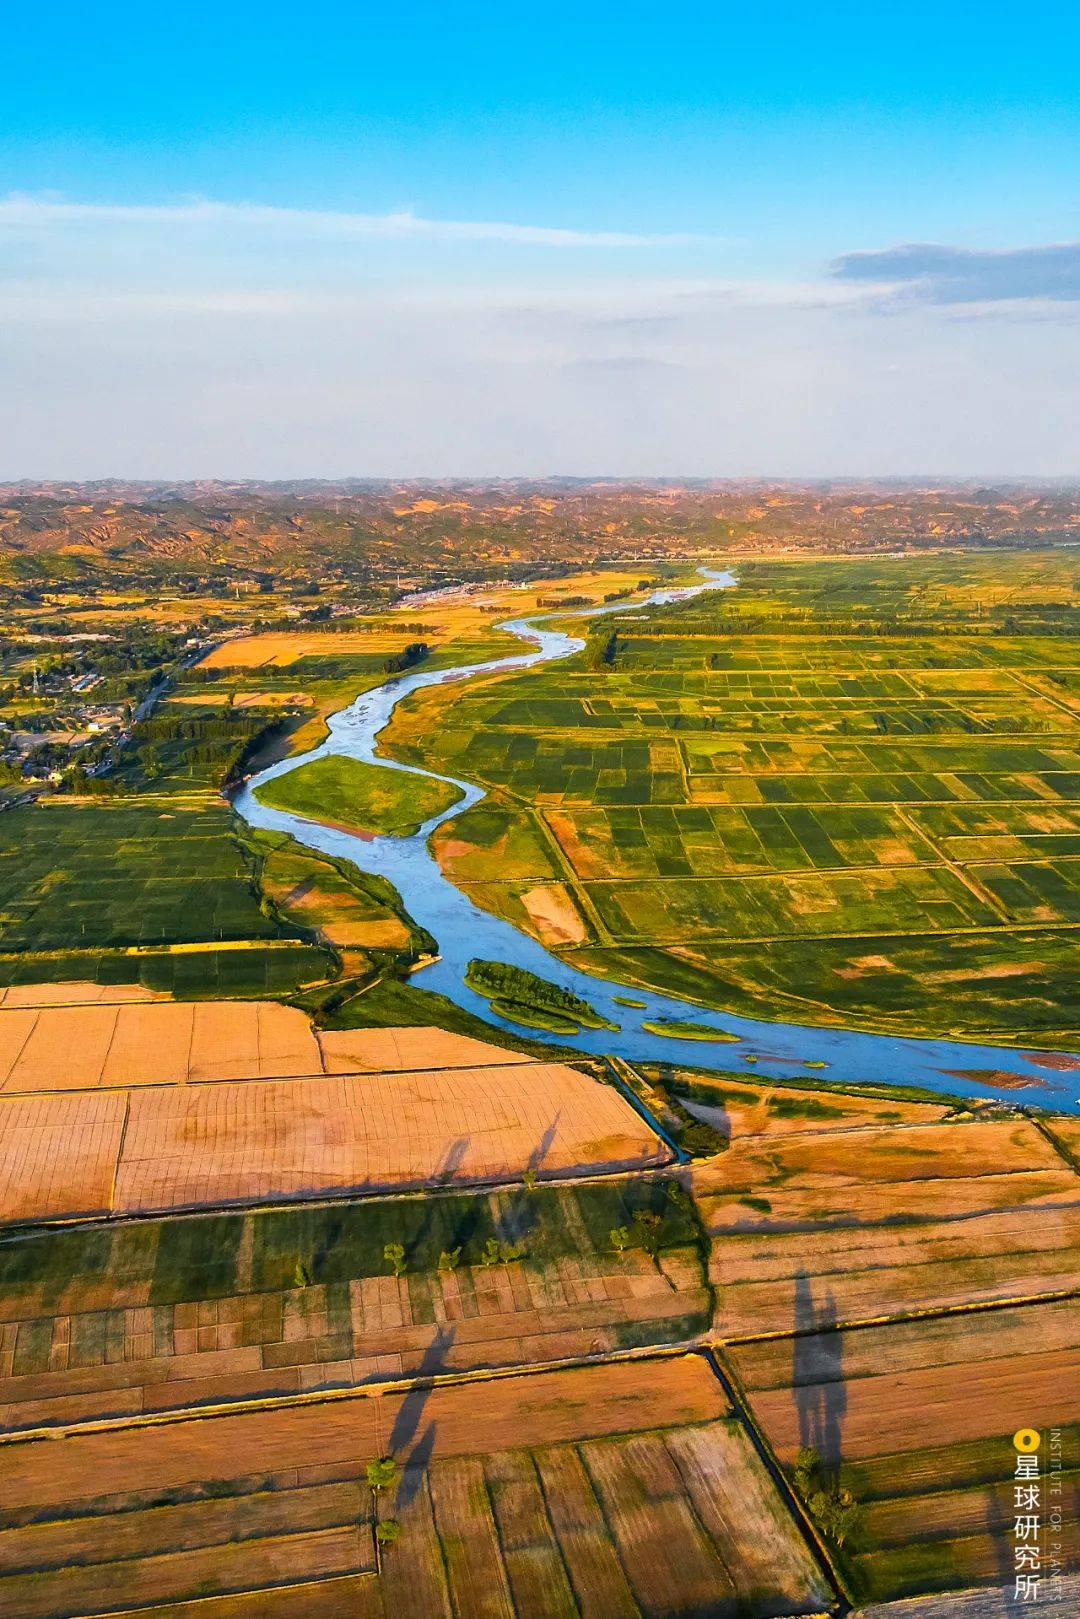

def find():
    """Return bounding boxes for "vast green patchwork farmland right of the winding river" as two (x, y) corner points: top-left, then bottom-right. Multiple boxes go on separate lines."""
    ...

(375, 550), (1080, 1046)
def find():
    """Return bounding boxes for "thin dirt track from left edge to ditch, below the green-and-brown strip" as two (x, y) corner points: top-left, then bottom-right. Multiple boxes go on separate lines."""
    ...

(0, 1339), (711, 1449)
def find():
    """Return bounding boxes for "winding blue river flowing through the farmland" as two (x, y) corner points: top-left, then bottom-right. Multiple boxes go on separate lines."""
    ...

(233, 568), (1080, 1109)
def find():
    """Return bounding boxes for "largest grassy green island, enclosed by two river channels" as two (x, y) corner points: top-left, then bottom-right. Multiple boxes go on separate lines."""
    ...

(256, 754), (461, 837)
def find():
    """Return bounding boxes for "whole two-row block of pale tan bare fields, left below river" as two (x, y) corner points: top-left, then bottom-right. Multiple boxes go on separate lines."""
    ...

(0, 1001), (670, 1221)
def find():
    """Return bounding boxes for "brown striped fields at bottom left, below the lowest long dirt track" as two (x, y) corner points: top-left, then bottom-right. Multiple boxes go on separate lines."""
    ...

(0, 1357), (832, 1619)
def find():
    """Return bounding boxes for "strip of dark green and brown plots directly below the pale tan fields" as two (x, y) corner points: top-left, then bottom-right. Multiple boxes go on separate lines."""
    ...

(0, 1177), (711, 1430)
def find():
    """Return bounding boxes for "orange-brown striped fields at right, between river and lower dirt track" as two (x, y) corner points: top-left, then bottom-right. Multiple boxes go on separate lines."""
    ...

(693, 1119), (1080, 1336)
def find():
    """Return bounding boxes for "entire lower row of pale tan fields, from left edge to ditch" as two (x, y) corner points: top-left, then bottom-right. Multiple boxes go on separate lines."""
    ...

(0, 1055), (669, 1221)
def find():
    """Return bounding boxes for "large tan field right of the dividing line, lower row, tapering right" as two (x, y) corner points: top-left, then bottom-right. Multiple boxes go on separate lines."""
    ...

(115, 1062), (667, 1213)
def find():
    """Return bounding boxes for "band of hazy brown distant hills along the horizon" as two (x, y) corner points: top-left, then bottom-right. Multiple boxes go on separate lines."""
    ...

(0, 479), (1080, 589)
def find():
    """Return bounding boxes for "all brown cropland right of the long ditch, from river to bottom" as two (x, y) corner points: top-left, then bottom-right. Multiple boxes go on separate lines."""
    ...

(669, 1073), (1080, 1613)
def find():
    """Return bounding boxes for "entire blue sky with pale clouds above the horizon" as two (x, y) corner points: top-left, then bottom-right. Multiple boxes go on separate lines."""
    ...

(0, 0), (1080, 478)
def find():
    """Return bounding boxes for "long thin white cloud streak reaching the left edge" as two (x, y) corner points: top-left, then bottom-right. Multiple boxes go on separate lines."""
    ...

(0, 194), (704, 248)
